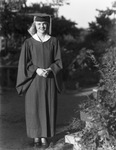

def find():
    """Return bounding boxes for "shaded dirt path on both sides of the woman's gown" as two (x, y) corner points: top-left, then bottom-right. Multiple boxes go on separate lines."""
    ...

(0, 89), (91, 150)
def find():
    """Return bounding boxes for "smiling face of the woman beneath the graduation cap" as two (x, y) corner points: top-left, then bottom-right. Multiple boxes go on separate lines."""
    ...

(35, 21), (48, 33)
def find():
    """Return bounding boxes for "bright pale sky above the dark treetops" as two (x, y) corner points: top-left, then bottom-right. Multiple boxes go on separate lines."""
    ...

(27, 0), (115, 28)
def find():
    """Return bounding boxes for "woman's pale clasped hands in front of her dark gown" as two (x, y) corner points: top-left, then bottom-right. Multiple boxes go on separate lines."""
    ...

(36, 68), (51, 78)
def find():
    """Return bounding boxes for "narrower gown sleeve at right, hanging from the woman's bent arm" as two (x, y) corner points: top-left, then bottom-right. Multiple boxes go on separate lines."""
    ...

(50, 39), (63, 93)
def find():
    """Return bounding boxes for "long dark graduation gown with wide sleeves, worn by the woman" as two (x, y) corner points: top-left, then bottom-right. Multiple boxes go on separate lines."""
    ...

(16, 37), (62, 138)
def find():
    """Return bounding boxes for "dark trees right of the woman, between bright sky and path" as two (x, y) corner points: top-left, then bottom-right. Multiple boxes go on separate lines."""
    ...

(61, 5), (116, 89)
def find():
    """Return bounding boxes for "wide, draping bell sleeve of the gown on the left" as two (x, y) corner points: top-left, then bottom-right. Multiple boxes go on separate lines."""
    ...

(16, 41), (38, 95)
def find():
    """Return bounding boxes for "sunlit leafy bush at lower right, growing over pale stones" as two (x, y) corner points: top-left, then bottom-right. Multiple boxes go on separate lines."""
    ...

(70, 47), (116, 150)
